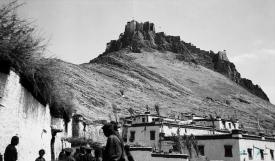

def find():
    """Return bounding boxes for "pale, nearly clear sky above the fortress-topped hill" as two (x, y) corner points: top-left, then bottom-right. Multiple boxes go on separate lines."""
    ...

(0, 0), (275, 104)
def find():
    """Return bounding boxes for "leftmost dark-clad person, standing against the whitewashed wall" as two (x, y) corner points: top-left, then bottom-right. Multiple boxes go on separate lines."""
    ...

(4, 136), (19, 161)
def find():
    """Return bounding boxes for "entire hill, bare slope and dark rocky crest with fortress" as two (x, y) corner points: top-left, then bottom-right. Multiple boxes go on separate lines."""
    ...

(28, 22), (275, 132)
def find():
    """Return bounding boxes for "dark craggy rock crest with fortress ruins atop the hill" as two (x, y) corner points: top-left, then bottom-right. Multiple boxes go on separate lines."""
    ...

(103, 20), (269, 101)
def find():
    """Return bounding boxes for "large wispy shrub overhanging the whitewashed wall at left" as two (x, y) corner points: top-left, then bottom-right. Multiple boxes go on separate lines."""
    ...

(0, 0), (73, 121)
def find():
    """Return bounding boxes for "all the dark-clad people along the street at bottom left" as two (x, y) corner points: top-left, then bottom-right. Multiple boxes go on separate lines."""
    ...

(1, 121), (135, 161)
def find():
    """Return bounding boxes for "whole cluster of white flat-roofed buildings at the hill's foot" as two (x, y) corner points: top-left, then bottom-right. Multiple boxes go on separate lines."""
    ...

(121, 112), (275, 161)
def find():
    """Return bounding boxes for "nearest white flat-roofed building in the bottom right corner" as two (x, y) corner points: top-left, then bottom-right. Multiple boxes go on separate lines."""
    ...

(190, 130), (275, 161)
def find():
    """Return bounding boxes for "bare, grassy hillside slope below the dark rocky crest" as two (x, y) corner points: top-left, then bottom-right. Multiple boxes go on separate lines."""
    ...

(50, 49), (275, 129)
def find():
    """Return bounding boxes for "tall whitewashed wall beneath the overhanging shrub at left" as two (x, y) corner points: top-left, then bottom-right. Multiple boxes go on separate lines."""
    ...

(0, 71), (51, 161)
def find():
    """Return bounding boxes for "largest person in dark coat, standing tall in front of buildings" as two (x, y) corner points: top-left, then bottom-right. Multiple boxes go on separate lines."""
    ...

(102, 123), (128, 161)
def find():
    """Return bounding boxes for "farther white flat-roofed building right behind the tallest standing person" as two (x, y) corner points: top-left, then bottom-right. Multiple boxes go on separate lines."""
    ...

(120, 112), (239, 146)
